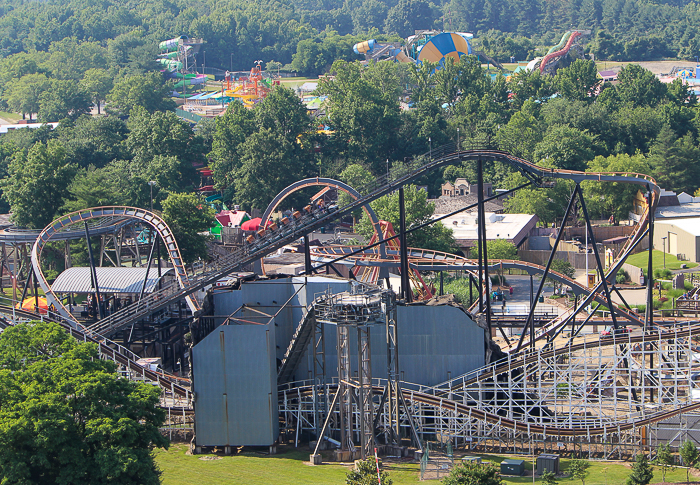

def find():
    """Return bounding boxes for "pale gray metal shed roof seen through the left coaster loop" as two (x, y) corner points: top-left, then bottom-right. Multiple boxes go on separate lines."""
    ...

(51, 267), (173, 293)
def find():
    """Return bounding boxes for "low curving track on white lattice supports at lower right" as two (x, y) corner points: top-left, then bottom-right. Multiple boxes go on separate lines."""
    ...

(279, 323), (700, 438)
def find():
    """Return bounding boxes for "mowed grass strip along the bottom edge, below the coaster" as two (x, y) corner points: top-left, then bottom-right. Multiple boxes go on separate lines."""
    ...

(155, 444), (692, 485)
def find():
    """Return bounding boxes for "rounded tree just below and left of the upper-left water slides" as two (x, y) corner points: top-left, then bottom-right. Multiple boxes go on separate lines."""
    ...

(107, 72), (175, 116)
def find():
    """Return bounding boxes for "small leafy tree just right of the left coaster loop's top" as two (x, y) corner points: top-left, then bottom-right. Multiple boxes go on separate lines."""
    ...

(163, 194), (216, 263)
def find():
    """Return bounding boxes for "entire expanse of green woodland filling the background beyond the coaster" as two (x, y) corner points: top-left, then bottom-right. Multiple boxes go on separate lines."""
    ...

(0, 0), (700, 260)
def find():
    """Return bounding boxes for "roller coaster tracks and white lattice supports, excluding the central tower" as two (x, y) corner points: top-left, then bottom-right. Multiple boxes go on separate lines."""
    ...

(0, 139), (688, 453)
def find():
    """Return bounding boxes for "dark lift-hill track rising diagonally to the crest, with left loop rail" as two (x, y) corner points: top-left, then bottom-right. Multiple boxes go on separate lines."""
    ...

(32, 140), (660, 344)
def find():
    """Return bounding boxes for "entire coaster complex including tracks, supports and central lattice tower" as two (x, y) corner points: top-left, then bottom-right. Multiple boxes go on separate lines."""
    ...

(0, 139), (700, 456)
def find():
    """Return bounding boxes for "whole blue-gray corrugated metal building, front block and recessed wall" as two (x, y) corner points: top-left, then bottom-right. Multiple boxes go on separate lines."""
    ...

(193, 276), (485, 446)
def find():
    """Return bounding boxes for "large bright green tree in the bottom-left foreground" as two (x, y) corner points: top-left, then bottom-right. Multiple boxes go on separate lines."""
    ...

(0, 322), (168, 485)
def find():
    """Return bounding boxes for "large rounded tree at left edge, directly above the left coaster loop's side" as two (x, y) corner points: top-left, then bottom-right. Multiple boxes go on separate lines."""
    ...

(0, 140), (76, 229)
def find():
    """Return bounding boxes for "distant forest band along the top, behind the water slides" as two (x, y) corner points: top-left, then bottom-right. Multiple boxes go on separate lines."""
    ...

(0, 0), (700, 76)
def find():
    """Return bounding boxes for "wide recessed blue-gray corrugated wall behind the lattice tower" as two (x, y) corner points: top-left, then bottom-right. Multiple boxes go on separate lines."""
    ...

(214, 276), (484, 385)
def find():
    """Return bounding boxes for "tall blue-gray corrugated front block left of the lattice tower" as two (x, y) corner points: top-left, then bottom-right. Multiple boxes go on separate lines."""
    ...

(192, 323), (279, 446)
